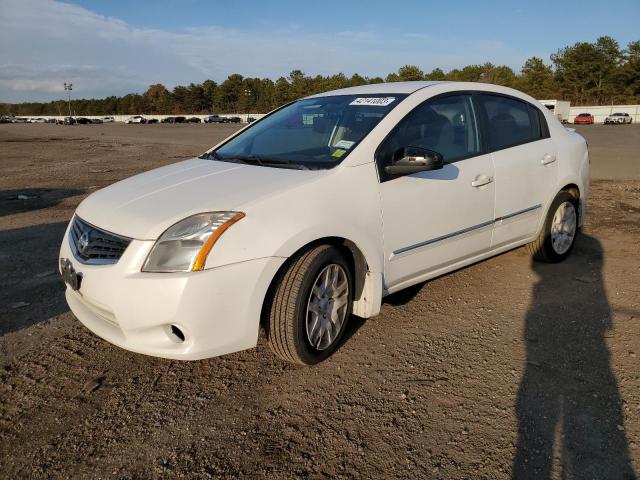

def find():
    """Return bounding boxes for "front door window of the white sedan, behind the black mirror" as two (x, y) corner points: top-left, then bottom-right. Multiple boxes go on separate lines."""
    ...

(378, 95), (480, 166)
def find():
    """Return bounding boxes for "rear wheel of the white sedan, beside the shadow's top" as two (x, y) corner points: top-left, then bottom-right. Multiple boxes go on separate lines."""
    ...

(529, 191), (580, 263)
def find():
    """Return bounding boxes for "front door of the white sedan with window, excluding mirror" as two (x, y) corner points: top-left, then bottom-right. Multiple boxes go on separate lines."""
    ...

(377, 94), (495, 292)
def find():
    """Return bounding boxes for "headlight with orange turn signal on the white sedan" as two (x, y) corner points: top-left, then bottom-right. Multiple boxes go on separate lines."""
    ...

(142, 212), (244, 272)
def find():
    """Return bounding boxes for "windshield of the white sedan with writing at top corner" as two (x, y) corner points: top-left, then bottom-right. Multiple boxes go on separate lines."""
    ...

(203, 94), (406, 169)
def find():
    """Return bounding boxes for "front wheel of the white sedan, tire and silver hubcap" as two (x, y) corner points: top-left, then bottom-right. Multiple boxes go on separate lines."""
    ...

(265, 245), (353, 365)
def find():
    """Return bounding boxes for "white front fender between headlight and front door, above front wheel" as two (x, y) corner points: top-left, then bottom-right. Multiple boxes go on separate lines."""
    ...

(206, 163), (383, 273)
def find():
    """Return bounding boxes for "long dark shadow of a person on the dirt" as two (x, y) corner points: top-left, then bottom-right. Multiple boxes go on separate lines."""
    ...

(513, 235), (636, 479)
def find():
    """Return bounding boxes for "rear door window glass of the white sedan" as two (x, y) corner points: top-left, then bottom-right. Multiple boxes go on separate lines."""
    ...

(481, 95), (544, 150)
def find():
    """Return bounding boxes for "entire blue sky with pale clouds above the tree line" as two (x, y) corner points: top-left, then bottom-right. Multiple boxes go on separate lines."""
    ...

(0, 0), (640, 102)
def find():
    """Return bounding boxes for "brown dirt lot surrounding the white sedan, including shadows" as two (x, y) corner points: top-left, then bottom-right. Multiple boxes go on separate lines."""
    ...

(0, 125), (640, 479)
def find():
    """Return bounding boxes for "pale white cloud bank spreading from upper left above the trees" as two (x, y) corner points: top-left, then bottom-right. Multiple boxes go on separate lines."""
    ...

(0, 0), (523, 101)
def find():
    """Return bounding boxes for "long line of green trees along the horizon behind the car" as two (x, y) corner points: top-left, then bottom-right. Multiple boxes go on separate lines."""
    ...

(0, 36), (640, 116)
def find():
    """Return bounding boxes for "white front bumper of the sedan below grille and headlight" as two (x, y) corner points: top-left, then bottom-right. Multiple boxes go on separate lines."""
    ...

(60, 225), (286, 360)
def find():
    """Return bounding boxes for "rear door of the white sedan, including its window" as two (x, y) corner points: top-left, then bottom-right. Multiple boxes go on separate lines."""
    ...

(478, 94), (558, 248)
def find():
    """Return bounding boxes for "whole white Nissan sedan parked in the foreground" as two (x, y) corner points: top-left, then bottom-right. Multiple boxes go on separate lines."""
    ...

(60, 82), (589, 364)
